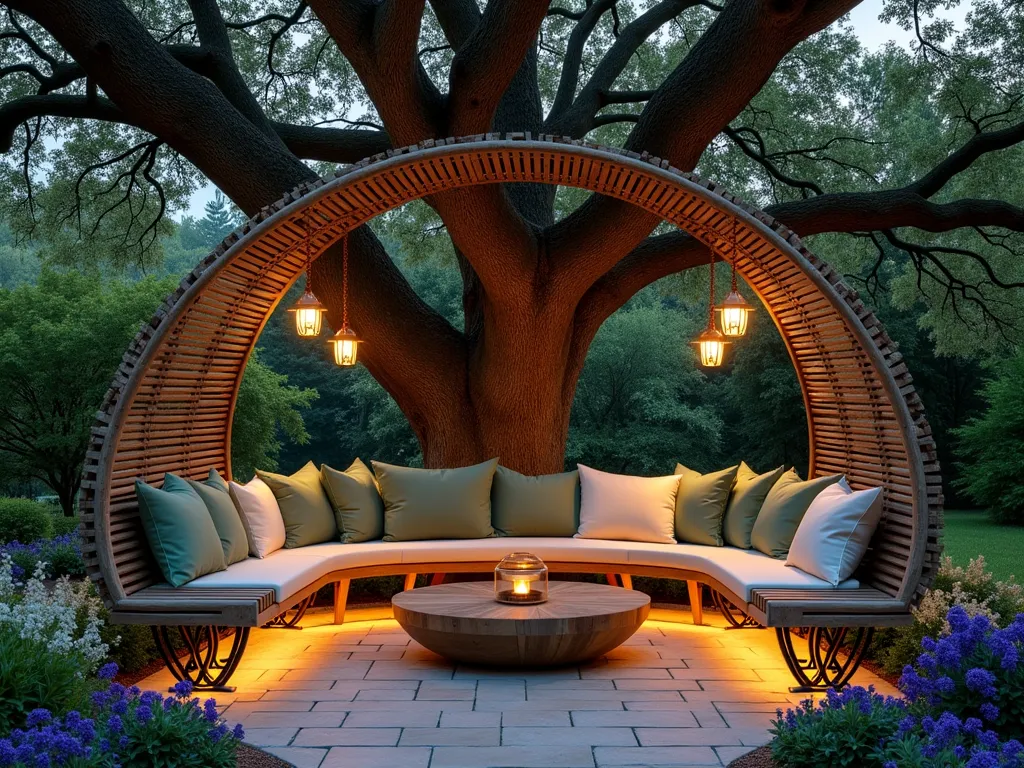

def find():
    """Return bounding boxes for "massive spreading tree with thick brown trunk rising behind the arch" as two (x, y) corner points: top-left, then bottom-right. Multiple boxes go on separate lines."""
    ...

(0, 0), (1024, 472)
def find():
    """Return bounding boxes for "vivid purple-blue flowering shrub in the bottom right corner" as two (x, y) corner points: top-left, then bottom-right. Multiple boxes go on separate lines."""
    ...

(772, 606), (1024, 768)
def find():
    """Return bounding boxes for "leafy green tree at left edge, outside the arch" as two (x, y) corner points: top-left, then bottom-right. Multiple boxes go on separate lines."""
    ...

(0, 269), (171, 514)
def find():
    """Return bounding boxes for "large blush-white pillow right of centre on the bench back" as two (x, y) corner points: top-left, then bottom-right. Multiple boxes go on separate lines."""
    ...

(575, 464), (679, 544)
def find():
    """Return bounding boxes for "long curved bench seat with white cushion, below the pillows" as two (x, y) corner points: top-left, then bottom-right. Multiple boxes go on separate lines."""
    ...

(182, 538), (860, 605)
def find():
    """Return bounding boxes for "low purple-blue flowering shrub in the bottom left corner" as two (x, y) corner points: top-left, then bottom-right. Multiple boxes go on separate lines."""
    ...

(0, 665), (244, 768)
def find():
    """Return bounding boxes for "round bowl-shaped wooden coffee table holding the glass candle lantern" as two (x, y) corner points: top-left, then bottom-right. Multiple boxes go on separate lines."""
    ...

(391, 582), (650, 667)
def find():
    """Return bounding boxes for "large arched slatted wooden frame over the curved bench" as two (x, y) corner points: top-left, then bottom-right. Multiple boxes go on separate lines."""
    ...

(82, 134), (942, 624)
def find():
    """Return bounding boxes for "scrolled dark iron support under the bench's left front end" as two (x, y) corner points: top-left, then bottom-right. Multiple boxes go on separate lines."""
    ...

(152, 626), (249, 693)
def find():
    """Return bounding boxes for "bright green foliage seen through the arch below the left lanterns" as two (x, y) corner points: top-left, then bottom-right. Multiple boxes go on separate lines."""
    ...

(231, 351), (318, 480)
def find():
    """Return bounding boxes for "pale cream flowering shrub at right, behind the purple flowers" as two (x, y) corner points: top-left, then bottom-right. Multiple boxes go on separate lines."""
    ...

(873, 556), (1024, 675)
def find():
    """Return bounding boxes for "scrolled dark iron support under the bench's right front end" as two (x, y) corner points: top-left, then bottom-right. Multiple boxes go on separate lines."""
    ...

(775, 627), (874, 693)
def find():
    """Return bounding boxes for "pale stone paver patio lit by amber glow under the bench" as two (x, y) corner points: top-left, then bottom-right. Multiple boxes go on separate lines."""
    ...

(139, 610), (895, 768)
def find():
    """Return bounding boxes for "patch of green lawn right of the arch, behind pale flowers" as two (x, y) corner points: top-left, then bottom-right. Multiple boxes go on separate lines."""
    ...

(944, 510), (1024, 582)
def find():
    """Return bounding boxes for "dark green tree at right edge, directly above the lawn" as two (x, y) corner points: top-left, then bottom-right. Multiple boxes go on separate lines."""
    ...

(955, 351), (1024, 525)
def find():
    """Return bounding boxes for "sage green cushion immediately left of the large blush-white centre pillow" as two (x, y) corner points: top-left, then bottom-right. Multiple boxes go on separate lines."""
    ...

(490, 467), (580, 537)
